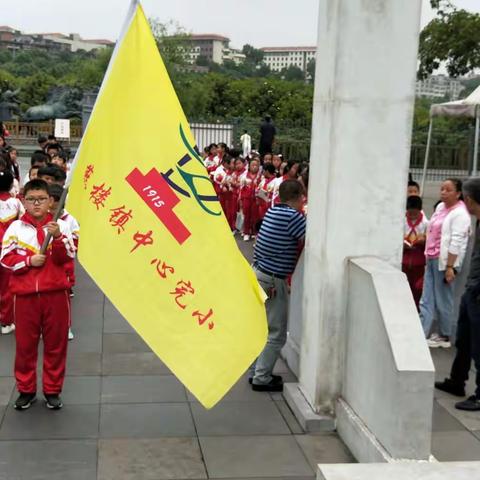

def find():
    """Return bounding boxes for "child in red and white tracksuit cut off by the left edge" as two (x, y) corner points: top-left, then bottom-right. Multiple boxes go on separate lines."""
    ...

(0, 170), (24, 335)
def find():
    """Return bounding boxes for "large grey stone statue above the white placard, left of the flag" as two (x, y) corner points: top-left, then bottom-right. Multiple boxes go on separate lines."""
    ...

(23, 87), (83, 122)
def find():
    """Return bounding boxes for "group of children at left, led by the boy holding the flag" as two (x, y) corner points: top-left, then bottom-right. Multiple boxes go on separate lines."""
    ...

(0, 136), (79, 410)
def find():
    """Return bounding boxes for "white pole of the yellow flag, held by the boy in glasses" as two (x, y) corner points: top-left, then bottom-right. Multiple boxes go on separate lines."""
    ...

(40, 0), (141, 255)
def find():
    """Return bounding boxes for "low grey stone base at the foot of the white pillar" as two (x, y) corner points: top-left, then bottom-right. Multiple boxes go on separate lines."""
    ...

(283, 383), (335, 433)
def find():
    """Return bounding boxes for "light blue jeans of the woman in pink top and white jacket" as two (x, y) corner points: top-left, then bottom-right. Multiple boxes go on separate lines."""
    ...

(420, 258), (455, 337)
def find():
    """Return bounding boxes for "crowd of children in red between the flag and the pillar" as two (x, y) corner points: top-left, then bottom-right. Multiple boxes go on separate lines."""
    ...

(203, 143), (308, 241)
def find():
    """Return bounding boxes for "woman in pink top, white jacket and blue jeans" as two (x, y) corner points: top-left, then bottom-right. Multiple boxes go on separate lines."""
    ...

(420, 178), (471, 348)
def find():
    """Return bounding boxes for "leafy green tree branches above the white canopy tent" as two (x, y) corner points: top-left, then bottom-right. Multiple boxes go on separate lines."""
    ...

(418, 0), (480, 78)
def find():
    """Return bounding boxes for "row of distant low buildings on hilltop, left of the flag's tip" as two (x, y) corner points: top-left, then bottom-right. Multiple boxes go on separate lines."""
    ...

(0, 26), (114, 52)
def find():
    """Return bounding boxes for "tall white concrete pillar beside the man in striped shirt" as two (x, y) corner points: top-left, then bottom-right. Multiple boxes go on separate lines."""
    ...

(299, 0), (421, 413)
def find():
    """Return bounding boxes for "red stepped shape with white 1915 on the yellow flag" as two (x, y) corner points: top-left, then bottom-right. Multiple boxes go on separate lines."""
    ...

(126, 168), (191, 245)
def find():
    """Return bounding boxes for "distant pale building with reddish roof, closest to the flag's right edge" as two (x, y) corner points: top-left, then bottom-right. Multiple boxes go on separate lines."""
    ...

(185, 33), (245, 65)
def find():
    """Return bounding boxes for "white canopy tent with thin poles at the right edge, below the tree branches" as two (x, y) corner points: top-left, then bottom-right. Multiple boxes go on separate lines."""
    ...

(421, 87), (480, 193)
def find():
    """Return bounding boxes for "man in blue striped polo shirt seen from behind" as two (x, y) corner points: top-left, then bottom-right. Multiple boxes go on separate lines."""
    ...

(250, 180), (306, 392)
